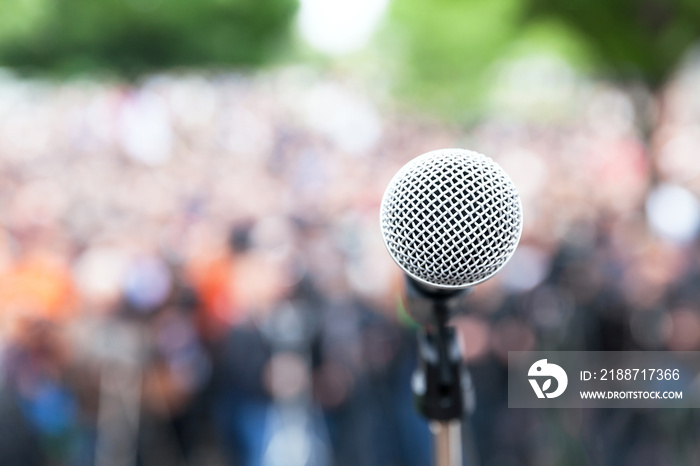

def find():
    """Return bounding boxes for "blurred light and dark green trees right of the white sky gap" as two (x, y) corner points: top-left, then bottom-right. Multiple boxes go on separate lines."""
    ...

(391, 0), (700, 119)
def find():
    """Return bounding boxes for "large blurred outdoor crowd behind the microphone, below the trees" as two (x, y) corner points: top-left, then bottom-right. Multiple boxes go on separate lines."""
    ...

(0, 56), (700, 466)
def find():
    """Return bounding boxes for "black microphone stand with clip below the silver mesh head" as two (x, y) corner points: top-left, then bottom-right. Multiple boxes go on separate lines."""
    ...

(407, 279), (473, 466)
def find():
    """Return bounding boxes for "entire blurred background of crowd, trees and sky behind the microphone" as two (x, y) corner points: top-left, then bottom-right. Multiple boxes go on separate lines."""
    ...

(0, 0), (700, 466)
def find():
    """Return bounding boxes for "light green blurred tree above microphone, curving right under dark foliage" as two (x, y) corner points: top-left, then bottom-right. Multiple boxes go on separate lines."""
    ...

(390, 0), (589, 120)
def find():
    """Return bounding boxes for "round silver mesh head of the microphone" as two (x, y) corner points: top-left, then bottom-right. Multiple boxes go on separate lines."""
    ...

(379, 149), (523, 290)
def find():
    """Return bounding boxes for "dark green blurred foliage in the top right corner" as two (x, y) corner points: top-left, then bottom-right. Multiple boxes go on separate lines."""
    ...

(527, 0), (700, 87)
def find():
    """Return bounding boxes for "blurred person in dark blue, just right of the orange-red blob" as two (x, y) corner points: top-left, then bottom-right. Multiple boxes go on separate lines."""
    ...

(205, 223), (287, 466)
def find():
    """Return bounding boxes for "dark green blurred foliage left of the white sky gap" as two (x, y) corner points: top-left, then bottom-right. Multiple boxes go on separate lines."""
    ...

(0, 0), (297, 76)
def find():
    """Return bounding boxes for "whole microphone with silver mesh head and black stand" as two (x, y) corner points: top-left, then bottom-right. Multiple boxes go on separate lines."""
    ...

(379, 149), (523, 440)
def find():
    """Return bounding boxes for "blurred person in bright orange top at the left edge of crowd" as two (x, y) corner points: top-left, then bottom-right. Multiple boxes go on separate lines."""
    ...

(0, 228), (79, 464)
